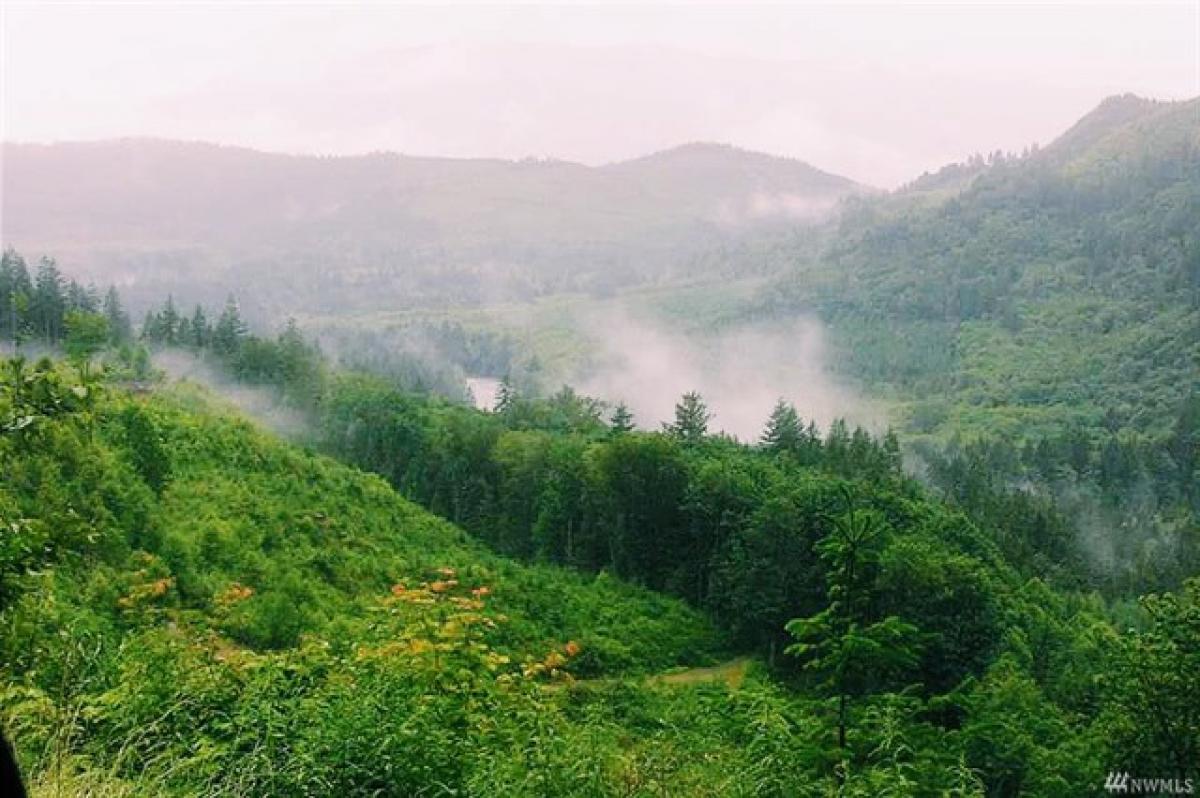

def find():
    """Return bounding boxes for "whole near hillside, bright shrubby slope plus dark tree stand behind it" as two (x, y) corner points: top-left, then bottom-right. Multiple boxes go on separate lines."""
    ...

(0, 352), (1200, 796)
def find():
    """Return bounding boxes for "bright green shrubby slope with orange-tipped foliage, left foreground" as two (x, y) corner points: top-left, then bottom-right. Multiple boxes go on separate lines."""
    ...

(0, 364), (801, 796)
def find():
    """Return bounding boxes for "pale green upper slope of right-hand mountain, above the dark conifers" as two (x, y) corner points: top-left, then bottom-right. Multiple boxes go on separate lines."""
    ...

(763, 96), (1200, 438)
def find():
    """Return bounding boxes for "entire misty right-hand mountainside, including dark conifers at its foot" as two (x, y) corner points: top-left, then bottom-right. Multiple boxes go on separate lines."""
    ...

(750, 96), (1200, 593)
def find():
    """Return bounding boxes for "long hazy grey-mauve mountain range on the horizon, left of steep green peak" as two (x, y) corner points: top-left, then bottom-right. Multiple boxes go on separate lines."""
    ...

(2, 139), (864, 313)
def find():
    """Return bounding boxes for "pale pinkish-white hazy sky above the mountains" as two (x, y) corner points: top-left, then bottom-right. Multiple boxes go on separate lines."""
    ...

(0, 0), (1200, 186)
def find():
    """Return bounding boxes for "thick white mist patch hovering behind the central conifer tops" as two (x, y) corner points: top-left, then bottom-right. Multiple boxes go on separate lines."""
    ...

(576, 311), (883, 442)
